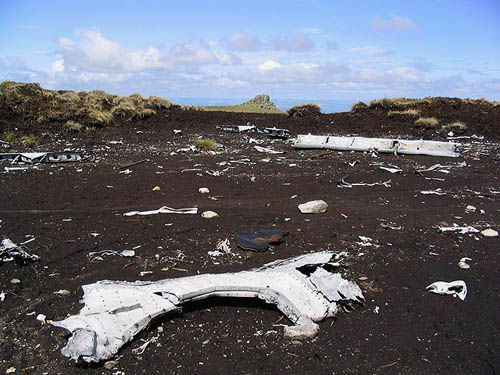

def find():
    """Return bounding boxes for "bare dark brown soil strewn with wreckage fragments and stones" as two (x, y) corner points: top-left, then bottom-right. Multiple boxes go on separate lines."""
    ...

(0, 100), (500, 375)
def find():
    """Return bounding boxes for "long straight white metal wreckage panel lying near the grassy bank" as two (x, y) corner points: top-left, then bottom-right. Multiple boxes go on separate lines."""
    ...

(293, 134), (460, 157)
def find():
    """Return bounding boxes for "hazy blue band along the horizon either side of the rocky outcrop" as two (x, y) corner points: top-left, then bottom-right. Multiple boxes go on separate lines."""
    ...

(169, 97), (356, 113)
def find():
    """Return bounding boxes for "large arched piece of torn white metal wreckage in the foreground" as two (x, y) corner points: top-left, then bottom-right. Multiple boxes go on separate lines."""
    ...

(50, 251), (364, 362)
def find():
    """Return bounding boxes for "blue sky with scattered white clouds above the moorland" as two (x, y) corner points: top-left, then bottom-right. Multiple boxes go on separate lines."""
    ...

(0, 0), (500, 101)
